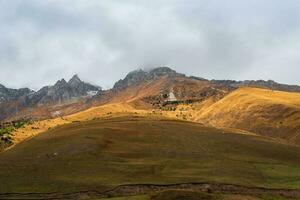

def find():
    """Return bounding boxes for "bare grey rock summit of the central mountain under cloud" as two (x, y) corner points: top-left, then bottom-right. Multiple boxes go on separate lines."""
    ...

(113, 67), (184, 91)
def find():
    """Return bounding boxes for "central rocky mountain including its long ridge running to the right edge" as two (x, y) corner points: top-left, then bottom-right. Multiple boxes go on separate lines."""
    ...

(110, 67), (300, 107)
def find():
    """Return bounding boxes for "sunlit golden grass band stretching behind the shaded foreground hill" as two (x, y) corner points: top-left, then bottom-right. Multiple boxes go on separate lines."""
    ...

(8, 84), (300, 150)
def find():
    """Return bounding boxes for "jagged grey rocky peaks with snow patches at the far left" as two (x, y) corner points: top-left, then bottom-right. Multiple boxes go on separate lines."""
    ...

(0, 75), (102, 120)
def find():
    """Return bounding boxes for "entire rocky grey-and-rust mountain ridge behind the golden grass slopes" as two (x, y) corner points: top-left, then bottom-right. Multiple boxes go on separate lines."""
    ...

(0, 67), (300, 120)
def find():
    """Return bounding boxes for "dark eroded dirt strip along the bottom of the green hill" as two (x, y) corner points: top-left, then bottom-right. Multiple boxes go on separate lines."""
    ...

(0, 183), (300, 200)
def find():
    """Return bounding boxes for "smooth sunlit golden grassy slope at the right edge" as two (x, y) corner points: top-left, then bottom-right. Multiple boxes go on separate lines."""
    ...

(195, 88), (300, 144)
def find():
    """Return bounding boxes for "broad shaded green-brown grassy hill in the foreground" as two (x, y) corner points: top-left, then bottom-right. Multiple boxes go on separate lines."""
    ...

(0, 117), (300, 198)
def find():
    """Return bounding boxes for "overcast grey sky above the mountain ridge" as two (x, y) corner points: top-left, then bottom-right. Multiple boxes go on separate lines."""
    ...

(0, 0), (300, 89)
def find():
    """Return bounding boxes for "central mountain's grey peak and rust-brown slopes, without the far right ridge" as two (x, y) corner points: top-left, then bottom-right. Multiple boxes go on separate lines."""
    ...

(110, 67), (230, 108)
